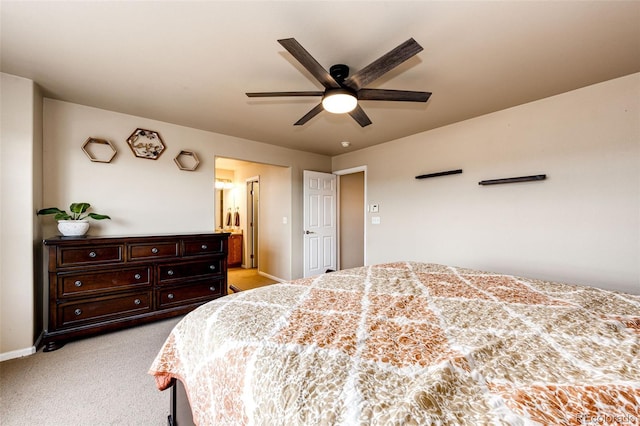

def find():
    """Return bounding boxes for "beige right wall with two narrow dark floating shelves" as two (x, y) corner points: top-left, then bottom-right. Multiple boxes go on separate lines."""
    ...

(333, 74), (640, 294)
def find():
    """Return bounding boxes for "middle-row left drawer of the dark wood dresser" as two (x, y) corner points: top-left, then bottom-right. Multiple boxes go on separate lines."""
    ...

(58, 266), (151, 298)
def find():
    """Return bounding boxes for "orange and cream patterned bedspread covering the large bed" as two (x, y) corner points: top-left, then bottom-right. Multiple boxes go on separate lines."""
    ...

(150, 262), (640, 426)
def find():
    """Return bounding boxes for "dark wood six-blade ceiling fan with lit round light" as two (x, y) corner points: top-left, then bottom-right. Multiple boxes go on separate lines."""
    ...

(246, 38), (431, 127)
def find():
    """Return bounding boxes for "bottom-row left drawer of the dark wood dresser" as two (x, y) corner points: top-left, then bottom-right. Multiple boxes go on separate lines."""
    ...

(57, 291), (152, 327)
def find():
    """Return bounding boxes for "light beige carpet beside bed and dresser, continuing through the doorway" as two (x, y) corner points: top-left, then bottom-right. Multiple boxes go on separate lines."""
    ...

(0, 268), (275, 426)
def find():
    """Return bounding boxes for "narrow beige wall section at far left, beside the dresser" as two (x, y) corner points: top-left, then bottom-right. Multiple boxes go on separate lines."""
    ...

(0, 73), (42, 361)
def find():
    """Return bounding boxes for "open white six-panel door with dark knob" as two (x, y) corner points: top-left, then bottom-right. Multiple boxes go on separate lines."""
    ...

(303, 170), (337, 277)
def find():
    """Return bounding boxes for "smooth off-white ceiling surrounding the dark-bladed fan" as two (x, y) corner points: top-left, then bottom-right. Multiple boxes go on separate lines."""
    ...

(0, 0), (640, 155)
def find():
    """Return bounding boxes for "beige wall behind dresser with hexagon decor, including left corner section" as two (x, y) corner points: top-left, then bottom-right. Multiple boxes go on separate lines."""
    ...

(0, 96), (331, 359)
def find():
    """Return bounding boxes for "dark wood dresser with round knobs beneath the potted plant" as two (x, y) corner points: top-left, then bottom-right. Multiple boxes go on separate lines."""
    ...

(43, 233), (229, 351)
